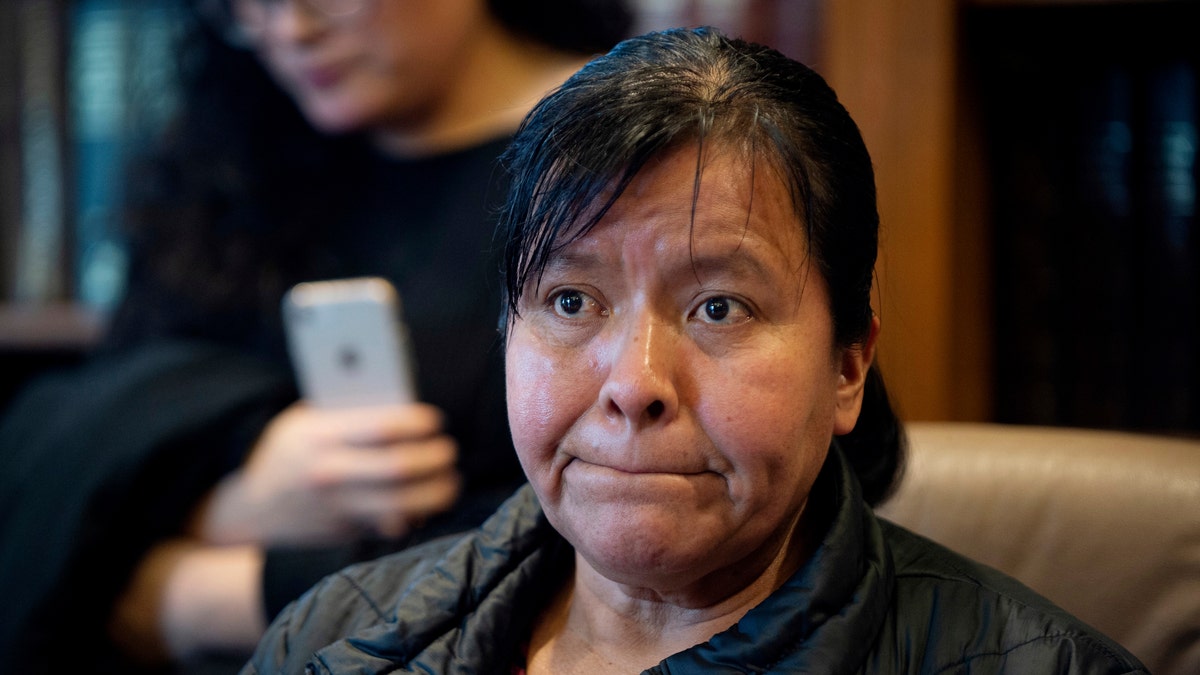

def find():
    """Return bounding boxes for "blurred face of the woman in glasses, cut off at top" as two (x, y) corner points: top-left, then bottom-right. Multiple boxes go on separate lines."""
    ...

(246, 0), (491, 133)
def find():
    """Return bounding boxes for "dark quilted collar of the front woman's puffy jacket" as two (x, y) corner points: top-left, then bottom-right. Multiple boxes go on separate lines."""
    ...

(316, 443), (894, 674)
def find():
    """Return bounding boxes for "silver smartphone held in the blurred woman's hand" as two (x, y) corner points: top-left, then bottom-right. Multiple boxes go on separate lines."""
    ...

(283, 276), (418, 408)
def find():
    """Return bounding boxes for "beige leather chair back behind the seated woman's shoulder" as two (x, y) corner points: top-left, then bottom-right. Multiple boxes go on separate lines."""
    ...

(878, 423), (1200, 675)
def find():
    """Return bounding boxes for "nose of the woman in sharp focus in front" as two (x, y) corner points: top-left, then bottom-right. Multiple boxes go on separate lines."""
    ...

(600, 315), (679, 426)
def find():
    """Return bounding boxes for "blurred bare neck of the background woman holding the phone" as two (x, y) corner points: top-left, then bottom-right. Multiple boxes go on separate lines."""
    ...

(373, 20), (587, 157)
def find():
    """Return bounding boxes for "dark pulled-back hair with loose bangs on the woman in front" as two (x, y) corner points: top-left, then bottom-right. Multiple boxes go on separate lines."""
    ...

(500, 28), (902, 503)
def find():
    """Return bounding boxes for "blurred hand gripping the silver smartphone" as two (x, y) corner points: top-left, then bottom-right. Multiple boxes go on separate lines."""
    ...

(191, 401), (461, 545)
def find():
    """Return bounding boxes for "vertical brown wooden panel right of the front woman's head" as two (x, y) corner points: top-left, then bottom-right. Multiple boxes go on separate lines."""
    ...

(821, 0), (991, 419)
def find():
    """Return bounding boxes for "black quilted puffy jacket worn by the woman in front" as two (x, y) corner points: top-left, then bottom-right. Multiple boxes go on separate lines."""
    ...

(242, 450), (1146, 675)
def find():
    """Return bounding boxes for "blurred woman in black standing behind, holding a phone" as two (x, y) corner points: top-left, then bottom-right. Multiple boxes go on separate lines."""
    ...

(0, 0), (631, 673)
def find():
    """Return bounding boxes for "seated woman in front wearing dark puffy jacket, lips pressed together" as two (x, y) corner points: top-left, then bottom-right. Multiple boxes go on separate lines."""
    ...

(245, 29), (1144, 674)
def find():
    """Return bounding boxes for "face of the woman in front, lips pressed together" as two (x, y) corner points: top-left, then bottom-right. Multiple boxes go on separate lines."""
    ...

(508, 147), (869, 591)
